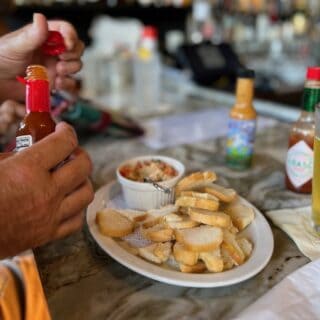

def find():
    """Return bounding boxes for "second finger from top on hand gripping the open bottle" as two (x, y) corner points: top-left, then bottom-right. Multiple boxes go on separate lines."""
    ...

(52, 148), (92, 194)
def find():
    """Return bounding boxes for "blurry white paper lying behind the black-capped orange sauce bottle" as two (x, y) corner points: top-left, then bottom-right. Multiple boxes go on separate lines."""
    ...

(143, 108), (277, 149)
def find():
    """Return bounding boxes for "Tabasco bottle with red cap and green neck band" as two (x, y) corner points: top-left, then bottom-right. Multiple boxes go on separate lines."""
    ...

(286, 67), (320, 193)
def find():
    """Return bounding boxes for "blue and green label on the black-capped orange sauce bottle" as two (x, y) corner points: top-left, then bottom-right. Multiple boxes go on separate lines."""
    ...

(227, 119), (256, 169)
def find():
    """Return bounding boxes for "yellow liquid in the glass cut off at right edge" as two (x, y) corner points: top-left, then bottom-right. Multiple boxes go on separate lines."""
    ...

(312, 137), (320, 233)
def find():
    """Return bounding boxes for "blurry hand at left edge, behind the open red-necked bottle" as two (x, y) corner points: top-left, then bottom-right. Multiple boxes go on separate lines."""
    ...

(0, 100), (25, 136)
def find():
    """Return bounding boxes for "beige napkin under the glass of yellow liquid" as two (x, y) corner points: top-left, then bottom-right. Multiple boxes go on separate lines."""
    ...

(266, 207), (320, 260)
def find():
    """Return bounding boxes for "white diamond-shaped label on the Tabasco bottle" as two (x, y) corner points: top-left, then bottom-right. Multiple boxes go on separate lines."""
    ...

(286, 140), (313, 188)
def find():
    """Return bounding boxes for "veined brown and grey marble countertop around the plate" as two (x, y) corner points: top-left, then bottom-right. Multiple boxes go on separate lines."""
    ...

(36, 95), (310, 320)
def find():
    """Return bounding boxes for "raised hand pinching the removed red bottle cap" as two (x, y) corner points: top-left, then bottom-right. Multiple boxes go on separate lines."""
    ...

(0, 13), (84, 94)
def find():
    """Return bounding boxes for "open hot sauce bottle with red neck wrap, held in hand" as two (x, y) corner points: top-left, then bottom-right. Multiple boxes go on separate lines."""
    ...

(16, 65), (56, 151)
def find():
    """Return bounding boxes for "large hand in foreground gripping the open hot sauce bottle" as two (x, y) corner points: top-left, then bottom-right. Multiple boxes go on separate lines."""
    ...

(0, 123), (93, 258)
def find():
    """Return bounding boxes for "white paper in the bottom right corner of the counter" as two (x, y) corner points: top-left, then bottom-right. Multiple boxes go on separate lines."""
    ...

(235, 259), (320, 320)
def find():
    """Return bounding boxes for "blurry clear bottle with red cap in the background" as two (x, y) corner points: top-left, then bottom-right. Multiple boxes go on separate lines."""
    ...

(131, 26), (161, 115)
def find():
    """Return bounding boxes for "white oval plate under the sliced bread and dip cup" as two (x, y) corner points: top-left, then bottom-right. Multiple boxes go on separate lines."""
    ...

(87, 181), (273, 288)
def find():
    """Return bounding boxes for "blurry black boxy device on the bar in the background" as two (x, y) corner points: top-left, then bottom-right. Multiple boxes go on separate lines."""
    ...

(176, 42), (243, 86)
